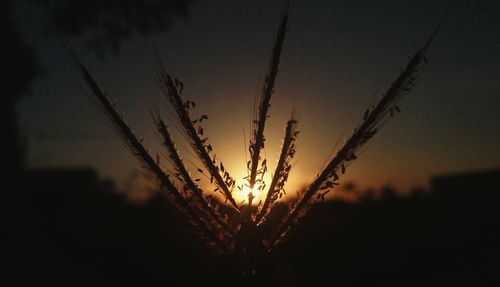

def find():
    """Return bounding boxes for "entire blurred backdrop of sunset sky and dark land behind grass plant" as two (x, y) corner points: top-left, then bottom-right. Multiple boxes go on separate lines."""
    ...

(0, 0), (500, 286)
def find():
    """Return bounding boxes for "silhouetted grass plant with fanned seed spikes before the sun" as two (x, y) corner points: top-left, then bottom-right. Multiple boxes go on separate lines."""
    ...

(63, 5), (441, 268)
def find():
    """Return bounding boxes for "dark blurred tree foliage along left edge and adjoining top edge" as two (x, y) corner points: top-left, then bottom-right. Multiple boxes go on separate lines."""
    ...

(0, 0), (192, 172)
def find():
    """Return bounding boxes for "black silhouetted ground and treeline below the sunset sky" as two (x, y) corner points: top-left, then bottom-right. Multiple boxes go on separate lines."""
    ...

(0, 169), (500, 286)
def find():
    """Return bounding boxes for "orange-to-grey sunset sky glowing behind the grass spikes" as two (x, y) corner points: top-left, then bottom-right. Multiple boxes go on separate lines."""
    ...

(15, 0), (500, 198)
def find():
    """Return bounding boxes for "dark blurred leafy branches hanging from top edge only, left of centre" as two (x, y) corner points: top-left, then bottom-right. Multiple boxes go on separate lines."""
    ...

(32, 0), (192, 53)
